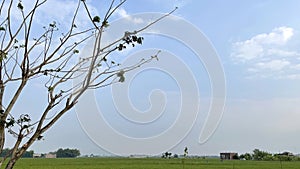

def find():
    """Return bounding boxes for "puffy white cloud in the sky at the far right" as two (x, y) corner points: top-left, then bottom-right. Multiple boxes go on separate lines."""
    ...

(231, 26), (300, 79)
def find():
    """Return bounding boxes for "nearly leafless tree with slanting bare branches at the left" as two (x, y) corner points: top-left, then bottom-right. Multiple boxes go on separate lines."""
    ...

(0, 0), (176, 169)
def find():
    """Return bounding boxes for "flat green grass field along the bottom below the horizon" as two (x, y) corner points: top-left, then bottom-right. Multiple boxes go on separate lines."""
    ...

(7, 158), (300, 169)
